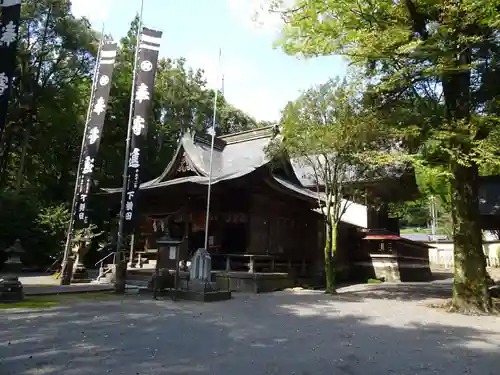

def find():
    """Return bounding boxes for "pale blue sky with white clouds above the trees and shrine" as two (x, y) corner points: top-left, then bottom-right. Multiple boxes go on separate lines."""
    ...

(72, 0), (346, 121)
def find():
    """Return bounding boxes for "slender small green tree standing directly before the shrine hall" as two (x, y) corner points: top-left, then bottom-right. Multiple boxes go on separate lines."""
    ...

(269, 80), (376, 293)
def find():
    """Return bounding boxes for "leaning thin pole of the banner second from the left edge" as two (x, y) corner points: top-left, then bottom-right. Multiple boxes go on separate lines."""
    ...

(61, 22), (105, 285)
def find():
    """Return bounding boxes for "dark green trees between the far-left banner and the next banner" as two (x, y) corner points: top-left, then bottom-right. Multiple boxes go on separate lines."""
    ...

(0, 0), (97, 266)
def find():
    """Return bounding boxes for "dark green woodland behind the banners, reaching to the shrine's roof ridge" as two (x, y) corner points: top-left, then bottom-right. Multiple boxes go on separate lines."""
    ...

(0, 8), (255, 265)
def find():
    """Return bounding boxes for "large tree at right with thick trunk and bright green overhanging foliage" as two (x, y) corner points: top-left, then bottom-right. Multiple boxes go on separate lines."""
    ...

(272, 0), (500, 312)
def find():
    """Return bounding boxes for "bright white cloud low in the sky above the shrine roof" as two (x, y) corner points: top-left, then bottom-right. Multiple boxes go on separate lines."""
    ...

(186, 50), (282, 121)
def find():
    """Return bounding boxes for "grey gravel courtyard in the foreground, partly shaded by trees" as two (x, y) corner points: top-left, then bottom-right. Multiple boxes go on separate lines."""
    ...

(0, 282), (500, 375)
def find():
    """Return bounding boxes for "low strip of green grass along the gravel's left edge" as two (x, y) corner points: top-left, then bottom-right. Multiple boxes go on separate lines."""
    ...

(0, 292), (121, 310)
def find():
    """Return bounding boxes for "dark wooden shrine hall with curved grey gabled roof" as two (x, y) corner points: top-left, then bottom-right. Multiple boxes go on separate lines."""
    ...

(104, 126), (430, 292)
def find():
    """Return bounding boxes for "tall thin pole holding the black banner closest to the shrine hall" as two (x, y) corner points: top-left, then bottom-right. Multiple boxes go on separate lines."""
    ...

(113, 0), (144, 292)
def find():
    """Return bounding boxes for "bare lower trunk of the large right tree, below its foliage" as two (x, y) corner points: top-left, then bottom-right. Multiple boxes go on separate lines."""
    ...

(450, 162), (493, 313)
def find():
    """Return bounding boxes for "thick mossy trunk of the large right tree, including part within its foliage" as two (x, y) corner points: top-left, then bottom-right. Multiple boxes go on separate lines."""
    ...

(442, 46), (493, 313)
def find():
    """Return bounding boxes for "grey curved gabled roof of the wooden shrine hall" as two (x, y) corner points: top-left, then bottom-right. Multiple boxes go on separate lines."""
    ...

(103, 126), (410, 199)
